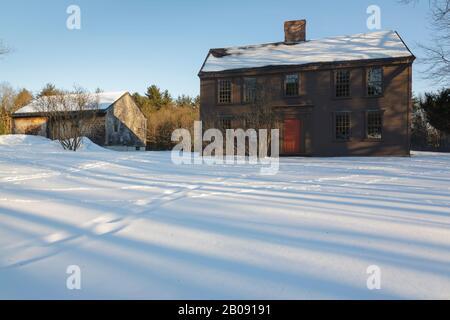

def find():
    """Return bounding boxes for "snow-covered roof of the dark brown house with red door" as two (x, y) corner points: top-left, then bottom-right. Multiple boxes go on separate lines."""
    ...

(200, 31), (413, 72)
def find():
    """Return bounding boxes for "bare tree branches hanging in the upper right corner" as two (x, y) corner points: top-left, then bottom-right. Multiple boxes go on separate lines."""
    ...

(400, 0), (450, 86)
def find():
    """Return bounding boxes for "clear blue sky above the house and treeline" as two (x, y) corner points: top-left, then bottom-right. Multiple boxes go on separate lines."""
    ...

(0, 0), (433, 96)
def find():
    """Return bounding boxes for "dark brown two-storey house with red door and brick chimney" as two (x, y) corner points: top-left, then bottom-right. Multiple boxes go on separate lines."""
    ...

(199, 20), (415, 156)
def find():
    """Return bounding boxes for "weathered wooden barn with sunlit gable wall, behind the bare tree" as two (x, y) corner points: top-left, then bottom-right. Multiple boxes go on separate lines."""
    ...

(13, 91), (147, 150)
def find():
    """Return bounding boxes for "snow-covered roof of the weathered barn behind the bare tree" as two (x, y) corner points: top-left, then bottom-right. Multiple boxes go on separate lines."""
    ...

(14, 91), (127, 114)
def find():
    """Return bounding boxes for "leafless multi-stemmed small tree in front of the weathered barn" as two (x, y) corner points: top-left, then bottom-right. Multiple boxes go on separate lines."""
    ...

(36, 88), (99, 151)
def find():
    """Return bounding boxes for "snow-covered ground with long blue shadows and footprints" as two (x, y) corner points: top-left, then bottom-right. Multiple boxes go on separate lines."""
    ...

(0, 136), (450, 299)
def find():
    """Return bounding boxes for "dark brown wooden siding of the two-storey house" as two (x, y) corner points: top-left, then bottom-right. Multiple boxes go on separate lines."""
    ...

(200, 60), (412, 156)
